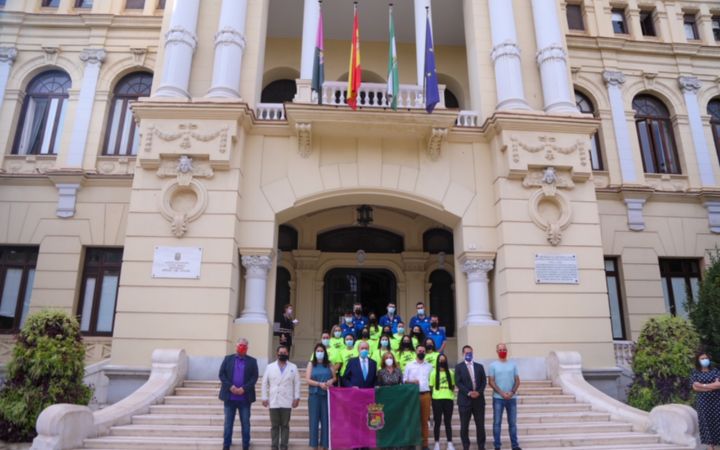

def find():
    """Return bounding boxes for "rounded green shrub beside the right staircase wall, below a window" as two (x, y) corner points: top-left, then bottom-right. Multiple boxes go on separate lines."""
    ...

(628, 316), (700, 411)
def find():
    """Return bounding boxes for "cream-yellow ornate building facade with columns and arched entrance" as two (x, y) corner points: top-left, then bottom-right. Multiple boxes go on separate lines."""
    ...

(0, 0), (720, 380)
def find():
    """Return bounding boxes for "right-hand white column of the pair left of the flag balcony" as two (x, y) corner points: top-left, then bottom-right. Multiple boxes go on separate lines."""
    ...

(207, 0), (247, 98)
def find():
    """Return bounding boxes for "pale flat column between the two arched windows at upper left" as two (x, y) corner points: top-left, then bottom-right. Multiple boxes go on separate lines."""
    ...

(66, 48), (107, 168)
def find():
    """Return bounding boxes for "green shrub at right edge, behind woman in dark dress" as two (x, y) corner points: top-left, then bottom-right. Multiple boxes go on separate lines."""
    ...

(687, 248), (720, 361)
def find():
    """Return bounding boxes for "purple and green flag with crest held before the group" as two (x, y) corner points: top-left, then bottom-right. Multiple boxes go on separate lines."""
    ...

(328, 384), (422, 448)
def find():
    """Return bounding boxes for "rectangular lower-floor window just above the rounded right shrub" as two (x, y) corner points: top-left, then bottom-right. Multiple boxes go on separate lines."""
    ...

(660, 259), (700, 318)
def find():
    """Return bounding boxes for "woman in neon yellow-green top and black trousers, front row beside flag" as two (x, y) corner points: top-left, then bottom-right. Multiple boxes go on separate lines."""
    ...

(426, 353), (455, 450)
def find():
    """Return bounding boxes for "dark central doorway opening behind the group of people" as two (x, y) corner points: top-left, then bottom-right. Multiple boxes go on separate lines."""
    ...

(323, 268), (397, 330)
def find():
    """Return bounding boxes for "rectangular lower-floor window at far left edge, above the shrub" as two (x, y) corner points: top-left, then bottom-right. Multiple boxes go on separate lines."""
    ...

(0, 247), (38, 331)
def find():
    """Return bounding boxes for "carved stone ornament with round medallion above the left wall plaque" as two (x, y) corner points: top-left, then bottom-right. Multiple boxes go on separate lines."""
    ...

(157, 155), (214, 238)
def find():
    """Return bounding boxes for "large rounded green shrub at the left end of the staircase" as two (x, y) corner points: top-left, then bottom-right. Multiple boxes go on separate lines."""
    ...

(0, 311), (92, 442)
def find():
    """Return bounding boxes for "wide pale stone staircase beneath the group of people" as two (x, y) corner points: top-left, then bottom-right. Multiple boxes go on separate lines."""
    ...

(73, 371), (688, 450)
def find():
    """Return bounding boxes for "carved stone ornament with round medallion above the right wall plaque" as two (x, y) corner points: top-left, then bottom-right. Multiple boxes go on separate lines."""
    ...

(523, 167), (572, 246)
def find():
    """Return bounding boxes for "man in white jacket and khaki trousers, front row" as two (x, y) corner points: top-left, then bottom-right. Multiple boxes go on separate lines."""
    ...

(261, 345), (300, 450)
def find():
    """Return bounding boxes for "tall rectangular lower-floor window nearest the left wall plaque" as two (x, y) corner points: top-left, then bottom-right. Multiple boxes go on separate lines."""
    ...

(78, 248), (122, 335)
